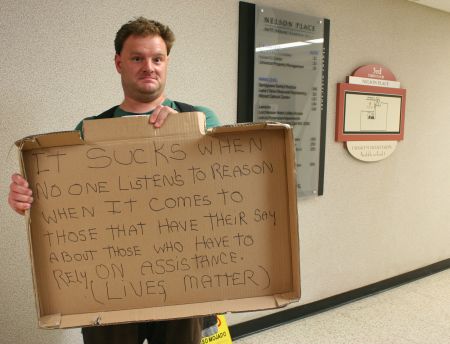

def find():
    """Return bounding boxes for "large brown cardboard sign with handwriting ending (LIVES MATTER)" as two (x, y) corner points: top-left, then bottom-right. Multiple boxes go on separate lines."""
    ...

(18, 113), (300, 328)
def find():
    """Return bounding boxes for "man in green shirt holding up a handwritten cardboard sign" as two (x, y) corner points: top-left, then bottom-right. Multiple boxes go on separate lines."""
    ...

(8, 17), (219, 344)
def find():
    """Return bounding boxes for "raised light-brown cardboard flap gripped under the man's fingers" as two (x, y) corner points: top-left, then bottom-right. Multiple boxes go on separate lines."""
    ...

(83, 112), (206, 143)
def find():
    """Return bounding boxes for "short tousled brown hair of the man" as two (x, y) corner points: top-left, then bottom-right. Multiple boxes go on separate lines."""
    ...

(114, 17), (175, 55)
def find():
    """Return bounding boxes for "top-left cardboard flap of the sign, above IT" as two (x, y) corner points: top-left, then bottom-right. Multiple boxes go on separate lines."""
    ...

(15, 130), (83, 151)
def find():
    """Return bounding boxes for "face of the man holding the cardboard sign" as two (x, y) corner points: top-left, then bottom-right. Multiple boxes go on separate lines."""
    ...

(115, 35), (169, 102)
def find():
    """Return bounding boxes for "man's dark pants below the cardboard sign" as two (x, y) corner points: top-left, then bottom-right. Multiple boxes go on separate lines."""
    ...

(82, 318), (203, 344)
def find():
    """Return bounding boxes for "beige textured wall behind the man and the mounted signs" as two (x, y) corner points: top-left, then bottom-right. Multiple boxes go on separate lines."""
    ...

(0, 0), (450, 344)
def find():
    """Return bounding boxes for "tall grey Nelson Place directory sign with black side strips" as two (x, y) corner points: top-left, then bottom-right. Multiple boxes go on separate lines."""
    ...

(237, 2), (330, 197)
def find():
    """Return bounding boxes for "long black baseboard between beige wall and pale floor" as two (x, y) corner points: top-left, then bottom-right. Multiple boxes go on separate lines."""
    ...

(230, 258), (450, 339)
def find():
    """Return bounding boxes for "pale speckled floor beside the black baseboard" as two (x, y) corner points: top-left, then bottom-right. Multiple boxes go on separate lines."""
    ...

(233, 269), (450, 344)
